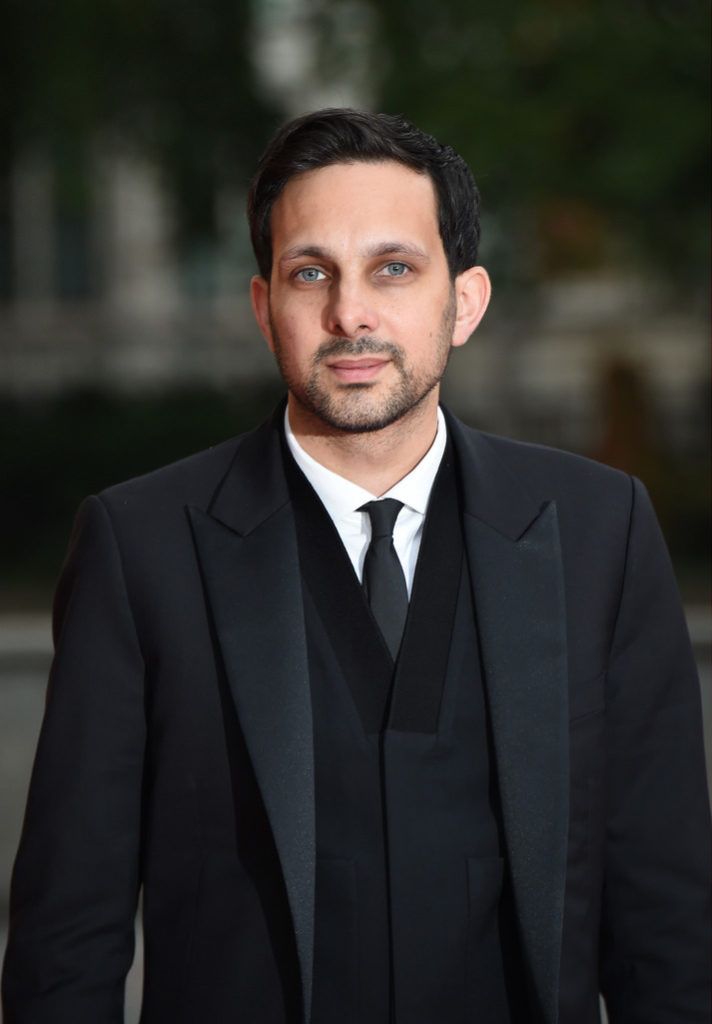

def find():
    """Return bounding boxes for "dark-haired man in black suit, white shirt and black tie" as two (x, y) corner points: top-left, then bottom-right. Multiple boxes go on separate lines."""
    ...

(4, 110), (710, 1024)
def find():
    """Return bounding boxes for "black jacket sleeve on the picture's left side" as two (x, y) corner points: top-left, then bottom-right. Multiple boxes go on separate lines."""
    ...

(2, 497), (145, 1024)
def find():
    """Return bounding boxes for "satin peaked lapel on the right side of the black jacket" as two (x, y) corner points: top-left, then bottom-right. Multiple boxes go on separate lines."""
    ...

(448, 418), (569, 1024)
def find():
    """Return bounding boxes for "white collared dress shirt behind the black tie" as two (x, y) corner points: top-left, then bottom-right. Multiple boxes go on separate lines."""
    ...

(285, 407), (447, 597)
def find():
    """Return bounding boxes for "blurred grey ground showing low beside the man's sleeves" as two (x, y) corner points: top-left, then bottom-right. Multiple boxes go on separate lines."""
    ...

(0, 607), (712, 1024)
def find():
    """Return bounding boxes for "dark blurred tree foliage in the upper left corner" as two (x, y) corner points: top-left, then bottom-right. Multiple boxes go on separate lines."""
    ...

(0, 0), (276, 256)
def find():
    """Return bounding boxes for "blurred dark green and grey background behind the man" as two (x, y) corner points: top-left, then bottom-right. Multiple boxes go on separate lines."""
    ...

(0, 0), (712, 1019)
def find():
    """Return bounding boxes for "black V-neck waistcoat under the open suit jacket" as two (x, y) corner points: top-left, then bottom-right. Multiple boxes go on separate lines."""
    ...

(285, 445), (512, 1024)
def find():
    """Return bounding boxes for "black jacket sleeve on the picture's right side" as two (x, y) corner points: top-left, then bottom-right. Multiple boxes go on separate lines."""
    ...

(600, 480), (712, 1024)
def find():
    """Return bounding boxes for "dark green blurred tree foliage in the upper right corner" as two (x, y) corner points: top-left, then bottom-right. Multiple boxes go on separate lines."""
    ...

(312, 0), (710, 287)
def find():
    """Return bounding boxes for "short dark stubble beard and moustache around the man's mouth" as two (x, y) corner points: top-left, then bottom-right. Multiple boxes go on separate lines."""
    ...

(271, 290), (455, 433)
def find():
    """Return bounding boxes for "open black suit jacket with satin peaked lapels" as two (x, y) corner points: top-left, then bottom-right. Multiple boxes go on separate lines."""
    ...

(3, 405), (710, 1024)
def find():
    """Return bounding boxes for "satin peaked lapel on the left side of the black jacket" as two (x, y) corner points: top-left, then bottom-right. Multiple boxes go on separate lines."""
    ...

(187, 411), (316, 1021)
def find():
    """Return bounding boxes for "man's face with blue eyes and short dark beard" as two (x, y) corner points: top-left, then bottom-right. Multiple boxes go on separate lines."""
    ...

(253, 162), (479, 432)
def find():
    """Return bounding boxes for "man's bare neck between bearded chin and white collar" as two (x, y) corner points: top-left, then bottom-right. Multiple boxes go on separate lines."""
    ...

(289, 389), (438, 495)
